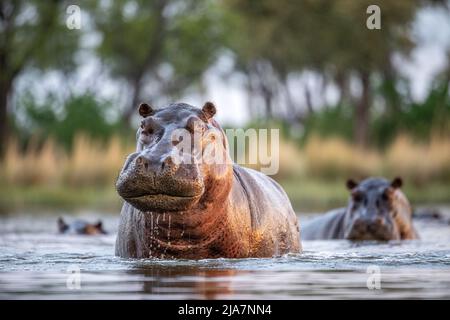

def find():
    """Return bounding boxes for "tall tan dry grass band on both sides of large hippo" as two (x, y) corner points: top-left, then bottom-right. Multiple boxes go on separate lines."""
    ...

(0, 135), (450, 187)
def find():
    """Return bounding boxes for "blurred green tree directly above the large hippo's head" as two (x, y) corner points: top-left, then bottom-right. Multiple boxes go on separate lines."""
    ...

(91, 0), (227, 122)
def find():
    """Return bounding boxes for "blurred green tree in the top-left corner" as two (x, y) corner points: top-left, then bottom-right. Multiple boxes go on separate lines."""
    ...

(0, 0), (79, 155)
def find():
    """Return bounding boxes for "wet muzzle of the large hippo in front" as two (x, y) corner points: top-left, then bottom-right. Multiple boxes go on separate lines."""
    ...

(116, 151), (204, 212)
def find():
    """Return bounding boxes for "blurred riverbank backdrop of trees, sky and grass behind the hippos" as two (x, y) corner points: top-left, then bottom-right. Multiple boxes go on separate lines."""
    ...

(0, 0), (450, 212)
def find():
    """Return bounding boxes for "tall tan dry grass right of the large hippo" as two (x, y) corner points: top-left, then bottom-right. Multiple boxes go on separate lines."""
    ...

(303, 135), (450, 184)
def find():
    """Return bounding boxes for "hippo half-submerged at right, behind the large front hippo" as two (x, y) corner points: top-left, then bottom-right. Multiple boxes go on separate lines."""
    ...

(302, 178), (418, 241)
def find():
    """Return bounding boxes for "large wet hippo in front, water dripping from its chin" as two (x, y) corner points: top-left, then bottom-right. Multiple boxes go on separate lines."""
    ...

(115, 102), (301, 259)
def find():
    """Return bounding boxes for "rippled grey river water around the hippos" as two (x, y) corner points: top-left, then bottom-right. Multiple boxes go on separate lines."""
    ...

(0, 212), (450, 299)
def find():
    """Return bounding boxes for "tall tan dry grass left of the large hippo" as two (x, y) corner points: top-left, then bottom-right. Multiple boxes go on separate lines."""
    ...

(0, 135), (132, 186)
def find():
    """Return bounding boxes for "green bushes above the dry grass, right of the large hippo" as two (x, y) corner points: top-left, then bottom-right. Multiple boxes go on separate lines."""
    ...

(301, 79), (450, 147)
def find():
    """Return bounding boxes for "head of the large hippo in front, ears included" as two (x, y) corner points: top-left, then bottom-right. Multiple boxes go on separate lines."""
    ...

(116, 102), (232, 212)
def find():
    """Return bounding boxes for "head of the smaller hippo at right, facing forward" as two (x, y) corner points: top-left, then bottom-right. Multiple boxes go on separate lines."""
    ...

(344, 178), (410, 241)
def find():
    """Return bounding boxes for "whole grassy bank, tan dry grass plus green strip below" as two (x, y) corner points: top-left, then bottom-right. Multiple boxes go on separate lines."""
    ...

(0, 132), (450, 212)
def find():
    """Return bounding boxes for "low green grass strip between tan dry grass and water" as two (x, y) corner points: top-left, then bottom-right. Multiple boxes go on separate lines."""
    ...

(0, 179), (450, 213)
